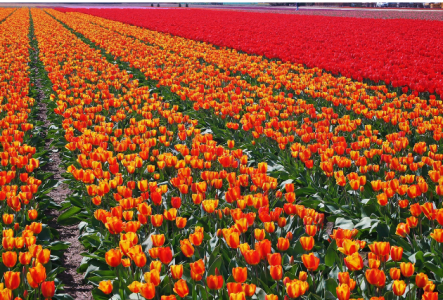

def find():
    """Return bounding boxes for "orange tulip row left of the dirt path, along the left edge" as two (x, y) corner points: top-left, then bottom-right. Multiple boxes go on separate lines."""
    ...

(0, 9), (55, 300)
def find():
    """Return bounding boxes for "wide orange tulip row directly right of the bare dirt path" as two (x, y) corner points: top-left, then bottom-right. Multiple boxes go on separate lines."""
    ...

(33, 10), (441, 299)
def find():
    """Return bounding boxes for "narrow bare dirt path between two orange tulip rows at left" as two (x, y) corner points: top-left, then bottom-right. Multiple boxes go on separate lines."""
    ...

(31, 22), (92, 300)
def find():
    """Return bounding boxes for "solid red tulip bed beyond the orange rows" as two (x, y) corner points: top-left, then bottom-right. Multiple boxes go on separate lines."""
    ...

(56, 9), (443, 95)
